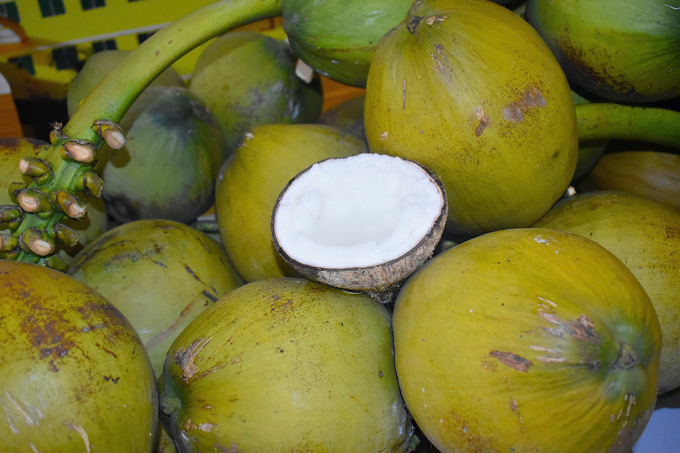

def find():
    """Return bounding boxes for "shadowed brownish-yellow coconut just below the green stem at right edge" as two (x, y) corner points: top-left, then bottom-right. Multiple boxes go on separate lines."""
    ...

(579, 149), (680, 209)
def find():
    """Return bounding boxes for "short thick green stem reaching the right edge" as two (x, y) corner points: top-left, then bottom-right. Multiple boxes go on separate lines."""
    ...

(576, 103), (680, 148)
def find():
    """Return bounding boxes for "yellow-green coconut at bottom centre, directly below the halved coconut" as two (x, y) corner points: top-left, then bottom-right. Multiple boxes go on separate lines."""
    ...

(161, 278), (412, 453)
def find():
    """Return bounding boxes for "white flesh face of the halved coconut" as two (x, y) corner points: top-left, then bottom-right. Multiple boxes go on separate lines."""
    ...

(274, 153), (444, 268)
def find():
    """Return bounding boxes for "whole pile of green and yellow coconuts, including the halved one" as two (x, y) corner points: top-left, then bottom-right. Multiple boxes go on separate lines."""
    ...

(0, 0), (680, 453)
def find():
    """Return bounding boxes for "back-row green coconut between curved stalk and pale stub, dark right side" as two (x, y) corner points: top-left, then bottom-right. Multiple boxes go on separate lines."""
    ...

(189, 31), (323, 151)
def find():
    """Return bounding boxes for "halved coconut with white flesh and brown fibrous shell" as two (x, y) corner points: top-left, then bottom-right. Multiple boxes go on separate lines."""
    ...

(271, 153), (448, 295)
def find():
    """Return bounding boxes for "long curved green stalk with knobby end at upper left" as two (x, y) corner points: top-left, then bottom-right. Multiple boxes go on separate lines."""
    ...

(5, 0), (282, 266)
